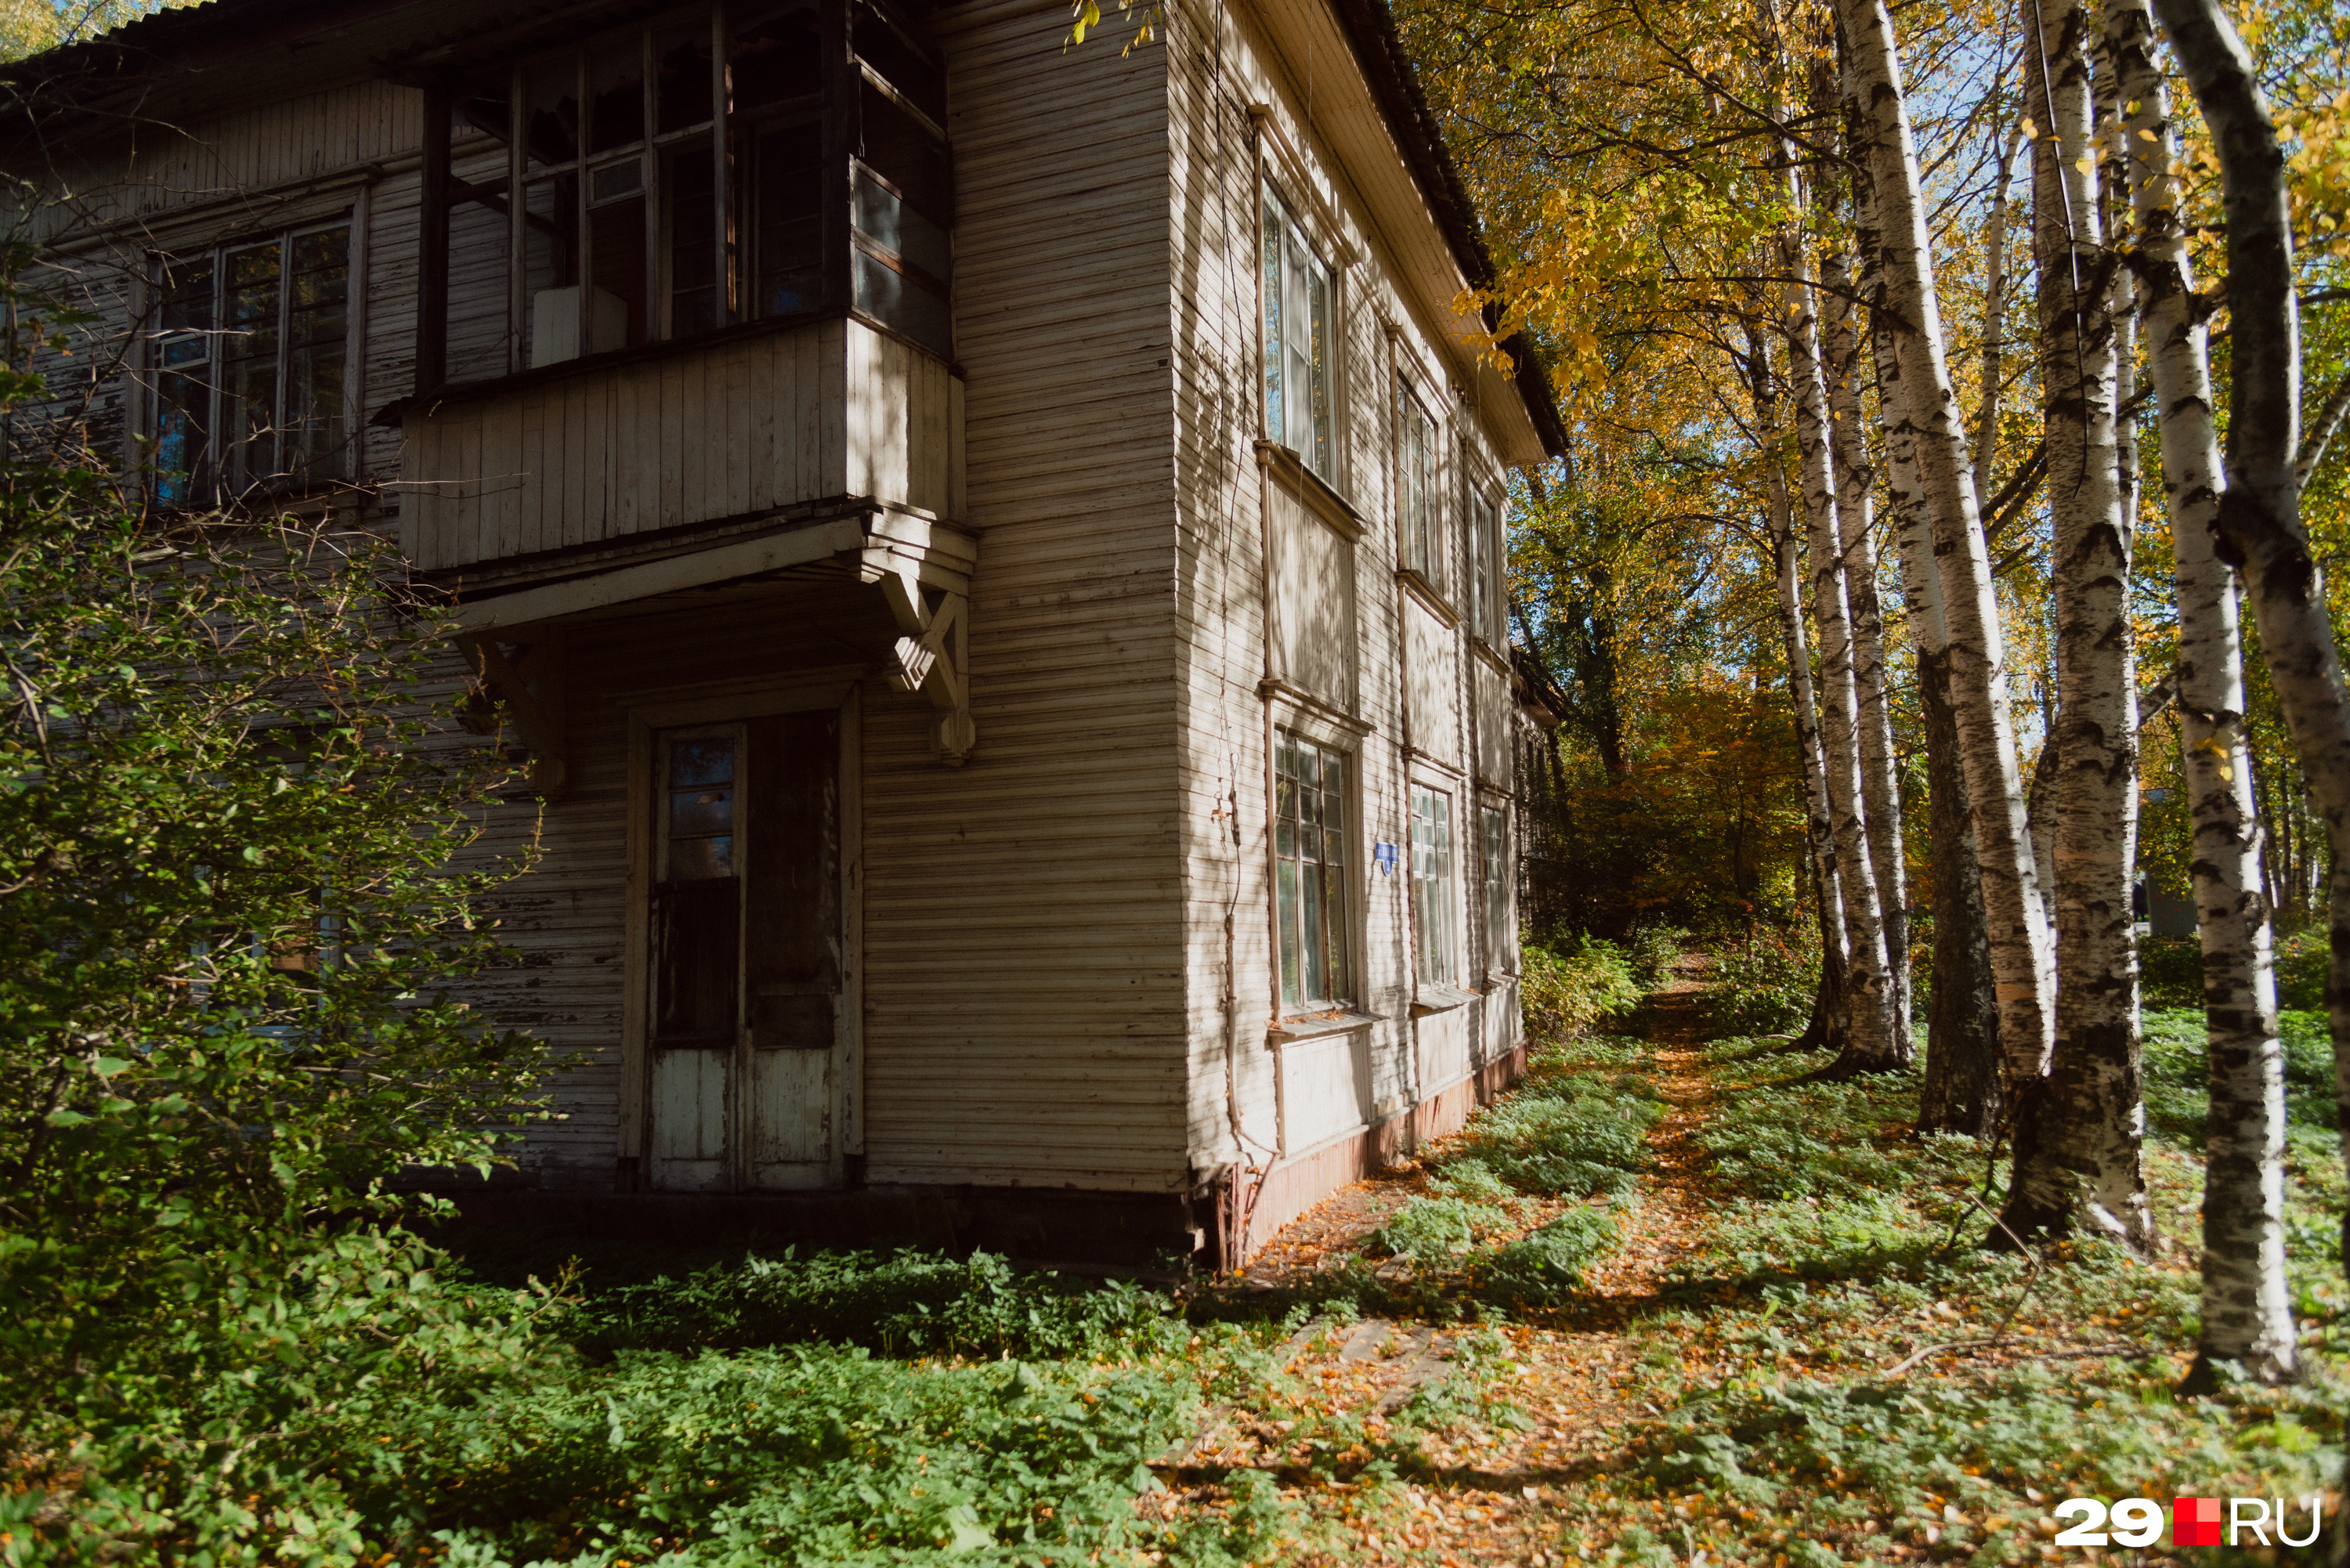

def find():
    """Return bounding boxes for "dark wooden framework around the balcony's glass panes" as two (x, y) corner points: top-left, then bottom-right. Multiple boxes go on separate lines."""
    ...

(414, 0), (954, 397)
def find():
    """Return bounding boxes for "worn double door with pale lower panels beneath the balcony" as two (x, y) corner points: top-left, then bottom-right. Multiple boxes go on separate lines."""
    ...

(646, 710), (844, 1192)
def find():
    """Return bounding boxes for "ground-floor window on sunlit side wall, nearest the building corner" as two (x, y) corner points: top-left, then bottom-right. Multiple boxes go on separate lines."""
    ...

(1274, 731), (1354, 1006)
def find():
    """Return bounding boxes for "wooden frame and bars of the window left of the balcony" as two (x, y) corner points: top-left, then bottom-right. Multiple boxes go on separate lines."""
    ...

(136, 221), (367, 508)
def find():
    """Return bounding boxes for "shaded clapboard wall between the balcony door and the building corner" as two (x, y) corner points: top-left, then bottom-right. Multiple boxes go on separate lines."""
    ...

(862, 7), (1187, 1192)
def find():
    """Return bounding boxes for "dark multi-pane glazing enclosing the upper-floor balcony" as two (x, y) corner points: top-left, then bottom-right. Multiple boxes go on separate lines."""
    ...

(432, 0), (952, 390)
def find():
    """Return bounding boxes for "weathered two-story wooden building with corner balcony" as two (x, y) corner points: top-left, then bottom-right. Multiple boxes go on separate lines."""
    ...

(12, 0), (1563, 1258)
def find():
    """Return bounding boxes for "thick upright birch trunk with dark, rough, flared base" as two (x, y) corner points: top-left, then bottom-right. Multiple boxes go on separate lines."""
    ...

(1995, 0), (2155, 1251)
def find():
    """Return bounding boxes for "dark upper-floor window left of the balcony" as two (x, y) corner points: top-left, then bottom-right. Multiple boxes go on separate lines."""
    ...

(150, 223), (350, 505)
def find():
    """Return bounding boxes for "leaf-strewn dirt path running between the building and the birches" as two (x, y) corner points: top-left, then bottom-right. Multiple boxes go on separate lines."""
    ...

(1163, 959), (1713, 1566)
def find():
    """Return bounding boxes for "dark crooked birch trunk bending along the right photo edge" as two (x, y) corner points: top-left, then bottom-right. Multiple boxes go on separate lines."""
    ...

(2155, 0), (2350, 1325)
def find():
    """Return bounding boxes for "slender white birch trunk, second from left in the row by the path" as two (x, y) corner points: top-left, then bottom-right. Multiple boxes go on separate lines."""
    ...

(1784, 240), (1906, 1068)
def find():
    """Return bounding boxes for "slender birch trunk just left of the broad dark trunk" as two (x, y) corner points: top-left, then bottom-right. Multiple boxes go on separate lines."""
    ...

(1821, 254), (1915, 1065)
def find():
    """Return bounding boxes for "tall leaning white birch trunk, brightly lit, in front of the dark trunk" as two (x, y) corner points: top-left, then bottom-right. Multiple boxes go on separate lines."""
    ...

(1838, 0), (2054, 1082)
